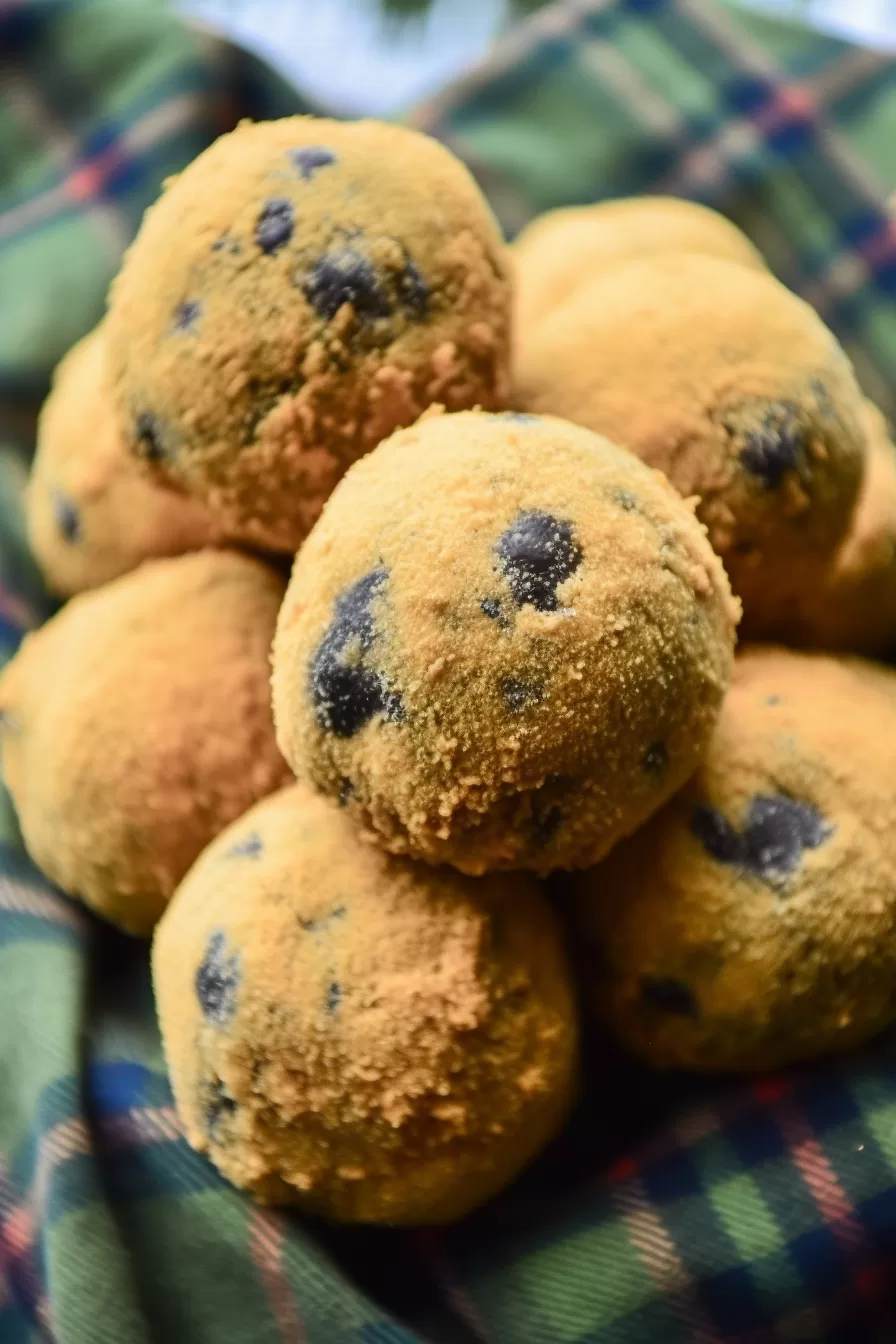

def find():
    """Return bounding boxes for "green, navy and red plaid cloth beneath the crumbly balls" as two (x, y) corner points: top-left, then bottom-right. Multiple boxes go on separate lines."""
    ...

(0, 0), (896, 1344)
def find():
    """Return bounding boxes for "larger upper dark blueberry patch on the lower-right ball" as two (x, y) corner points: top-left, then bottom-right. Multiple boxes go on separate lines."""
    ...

(690, 793), (833, 883)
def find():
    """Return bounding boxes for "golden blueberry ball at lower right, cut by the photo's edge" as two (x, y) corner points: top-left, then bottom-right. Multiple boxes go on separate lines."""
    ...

(576, 648), (896, 1070)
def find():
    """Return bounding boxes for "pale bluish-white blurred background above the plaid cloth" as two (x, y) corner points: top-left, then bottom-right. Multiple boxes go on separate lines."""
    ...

(175, 0), (896, 116)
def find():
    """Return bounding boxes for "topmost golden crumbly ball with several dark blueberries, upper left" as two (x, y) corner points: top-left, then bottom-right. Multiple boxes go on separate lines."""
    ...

(109, 117), (509, 550)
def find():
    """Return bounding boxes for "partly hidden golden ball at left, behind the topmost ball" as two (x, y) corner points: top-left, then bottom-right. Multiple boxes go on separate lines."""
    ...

(26, 325), (223, 597)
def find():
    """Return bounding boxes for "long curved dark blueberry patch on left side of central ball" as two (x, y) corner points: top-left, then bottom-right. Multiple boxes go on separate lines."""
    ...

(310, 569), (403, 738)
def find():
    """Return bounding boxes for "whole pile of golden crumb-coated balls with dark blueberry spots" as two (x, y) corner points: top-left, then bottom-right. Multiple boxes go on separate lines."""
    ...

(0, 118), (896, 1224)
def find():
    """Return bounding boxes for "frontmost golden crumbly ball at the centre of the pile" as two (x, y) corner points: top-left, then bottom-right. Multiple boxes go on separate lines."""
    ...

(274, 411), (737, 874)
